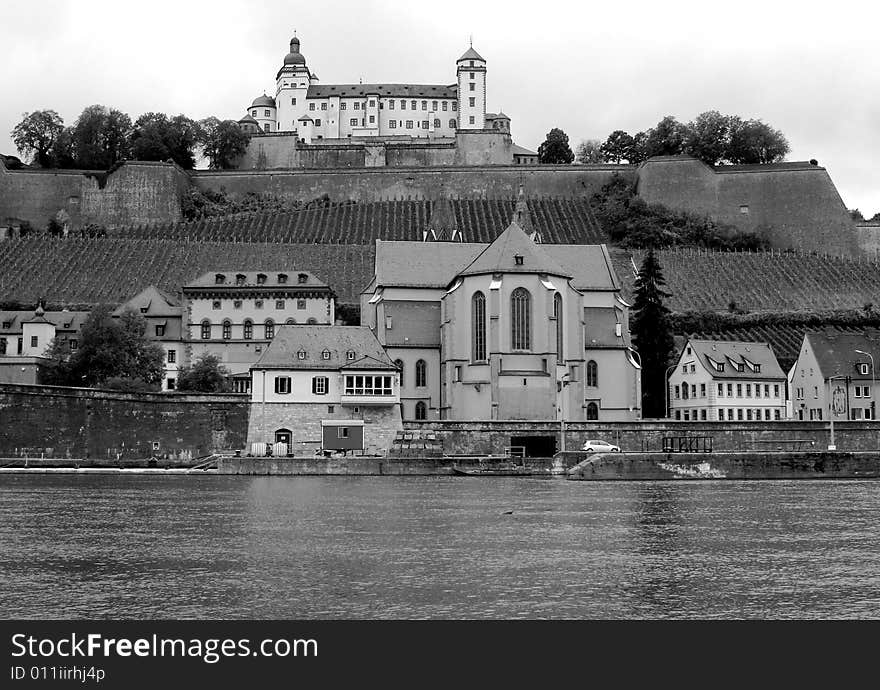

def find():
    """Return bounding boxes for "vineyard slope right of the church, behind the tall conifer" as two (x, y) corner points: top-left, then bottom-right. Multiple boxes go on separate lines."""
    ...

(612, 250), (880, 312)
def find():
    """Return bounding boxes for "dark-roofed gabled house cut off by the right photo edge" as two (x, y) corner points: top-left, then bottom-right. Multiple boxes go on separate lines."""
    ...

(790, 329), (880, 421)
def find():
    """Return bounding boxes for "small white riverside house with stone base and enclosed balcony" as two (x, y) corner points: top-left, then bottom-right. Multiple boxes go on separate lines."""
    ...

(248, 326), (403, 455)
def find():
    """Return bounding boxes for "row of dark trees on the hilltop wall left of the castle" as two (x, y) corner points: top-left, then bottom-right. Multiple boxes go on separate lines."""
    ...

(7, 105), (250, 170)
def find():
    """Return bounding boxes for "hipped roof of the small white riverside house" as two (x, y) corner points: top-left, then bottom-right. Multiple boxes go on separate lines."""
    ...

(251, 325), (395, 371)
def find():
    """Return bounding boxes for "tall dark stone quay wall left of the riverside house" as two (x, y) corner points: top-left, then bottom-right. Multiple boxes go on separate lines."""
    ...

(0, 384), (250, 461)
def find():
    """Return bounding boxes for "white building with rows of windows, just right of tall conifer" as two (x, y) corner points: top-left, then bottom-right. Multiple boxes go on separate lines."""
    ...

(667, 339), (787, 422)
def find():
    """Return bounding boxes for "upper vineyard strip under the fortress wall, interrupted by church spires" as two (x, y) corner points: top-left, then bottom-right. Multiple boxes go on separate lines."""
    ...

(110, 197), (608, 244)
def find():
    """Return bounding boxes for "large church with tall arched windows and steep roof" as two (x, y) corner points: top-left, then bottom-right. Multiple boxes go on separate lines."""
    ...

(361, 200), (641, 421)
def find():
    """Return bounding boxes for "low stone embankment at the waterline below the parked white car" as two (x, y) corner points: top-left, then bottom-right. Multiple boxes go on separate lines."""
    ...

(564, 451), (880, 481)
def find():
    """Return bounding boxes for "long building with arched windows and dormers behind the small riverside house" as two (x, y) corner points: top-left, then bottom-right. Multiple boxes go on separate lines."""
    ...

(183, 271), (336, 393)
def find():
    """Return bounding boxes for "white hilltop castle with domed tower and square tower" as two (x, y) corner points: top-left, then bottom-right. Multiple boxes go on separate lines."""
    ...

(239, 36), (510, 144)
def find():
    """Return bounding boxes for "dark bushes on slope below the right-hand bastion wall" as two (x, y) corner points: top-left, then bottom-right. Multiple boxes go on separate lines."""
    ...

(590, 173), (770, 251)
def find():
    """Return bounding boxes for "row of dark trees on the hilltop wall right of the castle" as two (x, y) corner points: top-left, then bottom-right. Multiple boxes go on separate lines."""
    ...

(576, 110), (790, 165)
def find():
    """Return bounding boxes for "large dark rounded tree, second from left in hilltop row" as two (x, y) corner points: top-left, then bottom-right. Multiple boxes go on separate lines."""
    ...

(72, 105), (131, 170)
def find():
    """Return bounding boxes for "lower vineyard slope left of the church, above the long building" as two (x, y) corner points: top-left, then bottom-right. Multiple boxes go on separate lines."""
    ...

(0, 237), (374, 304)
